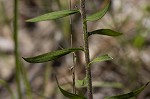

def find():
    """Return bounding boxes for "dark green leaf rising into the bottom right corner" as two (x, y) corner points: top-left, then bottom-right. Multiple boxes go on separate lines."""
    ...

(104, 82), (150, 99)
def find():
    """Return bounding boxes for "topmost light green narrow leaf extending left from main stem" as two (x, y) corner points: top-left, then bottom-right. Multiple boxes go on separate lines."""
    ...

(27, 10), (80, 22)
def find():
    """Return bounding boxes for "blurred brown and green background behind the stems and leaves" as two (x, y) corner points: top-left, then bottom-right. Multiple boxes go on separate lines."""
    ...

(0, 0), (150, 99)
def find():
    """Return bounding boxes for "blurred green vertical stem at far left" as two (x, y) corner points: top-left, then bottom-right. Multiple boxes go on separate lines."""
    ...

(13, 0), (22, 99)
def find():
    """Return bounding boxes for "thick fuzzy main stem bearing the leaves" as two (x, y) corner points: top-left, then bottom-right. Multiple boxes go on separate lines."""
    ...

(80, 0), (93, 99)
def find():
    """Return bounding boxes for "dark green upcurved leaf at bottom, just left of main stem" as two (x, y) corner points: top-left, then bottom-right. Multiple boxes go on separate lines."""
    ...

(56, 78), (87, 99)
